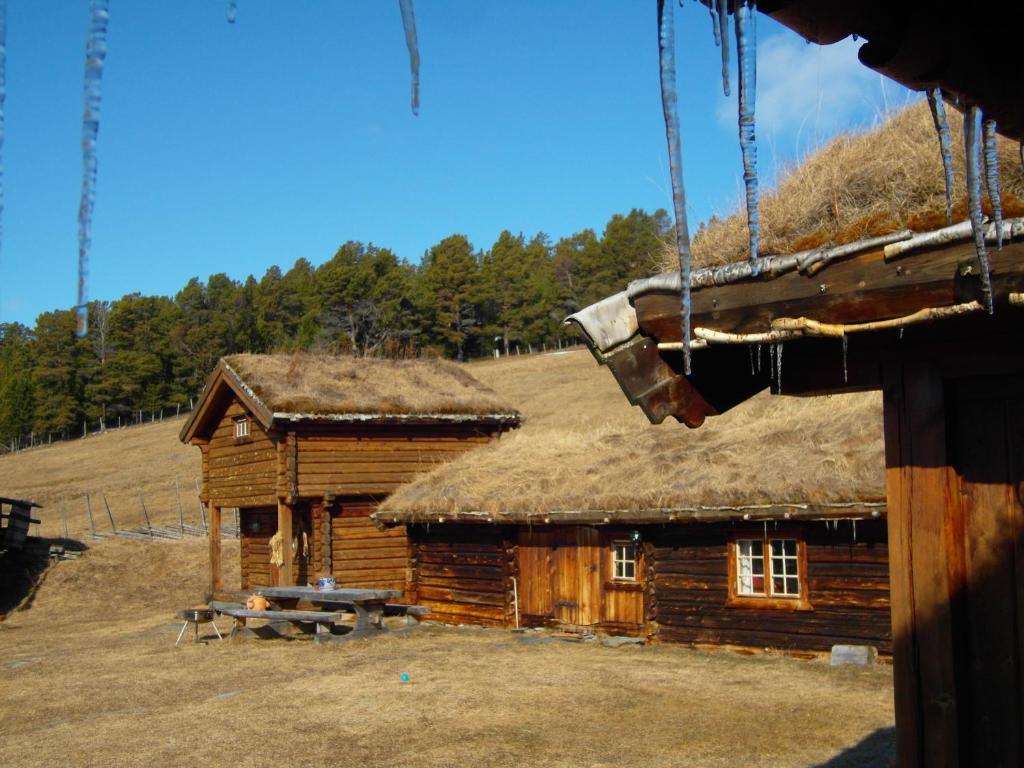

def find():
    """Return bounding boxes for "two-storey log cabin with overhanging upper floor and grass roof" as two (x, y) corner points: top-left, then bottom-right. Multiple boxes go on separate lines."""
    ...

(180, 354), (519, 594)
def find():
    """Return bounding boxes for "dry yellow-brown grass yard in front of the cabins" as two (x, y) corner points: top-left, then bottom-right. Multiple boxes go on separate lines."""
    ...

(0, 540), (893, 768)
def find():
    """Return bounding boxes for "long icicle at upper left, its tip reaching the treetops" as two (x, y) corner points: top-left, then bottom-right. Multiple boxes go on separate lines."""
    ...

(76, 0), (111, 337)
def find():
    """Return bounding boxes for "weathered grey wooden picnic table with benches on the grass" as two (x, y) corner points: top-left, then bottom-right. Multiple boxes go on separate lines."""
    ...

(221, 587), (426, 643)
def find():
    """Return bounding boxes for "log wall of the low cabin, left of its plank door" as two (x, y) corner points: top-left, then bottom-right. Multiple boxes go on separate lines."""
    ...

(409, 523), (517, 627)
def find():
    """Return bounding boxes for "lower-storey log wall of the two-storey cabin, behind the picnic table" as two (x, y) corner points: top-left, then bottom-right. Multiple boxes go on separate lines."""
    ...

(327, 500), (409, 592)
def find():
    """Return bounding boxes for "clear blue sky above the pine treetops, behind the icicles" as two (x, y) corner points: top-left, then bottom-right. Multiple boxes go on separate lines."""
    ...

(0, 0), (910, 324)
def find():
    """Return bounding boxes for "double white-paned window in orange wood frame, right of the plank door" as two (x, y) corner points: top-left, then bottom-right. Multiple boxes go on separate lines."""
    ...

(729, 534), (811, 609)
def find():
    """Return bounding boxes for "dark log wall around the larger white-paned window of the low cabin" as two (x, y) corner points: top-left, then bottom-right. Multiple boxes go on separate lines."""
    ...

(645, 520), (892, 653)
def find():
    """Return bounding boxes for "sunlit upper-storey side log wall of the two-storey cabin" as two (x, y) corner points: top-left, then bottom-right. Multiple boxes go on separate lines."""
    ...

(297, 425), (490, 498)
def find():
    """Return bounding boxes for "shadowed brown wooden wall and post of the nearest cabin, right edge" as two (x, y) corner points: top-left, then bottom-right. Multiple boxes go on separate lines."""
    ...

(883, 362), (1024, 768)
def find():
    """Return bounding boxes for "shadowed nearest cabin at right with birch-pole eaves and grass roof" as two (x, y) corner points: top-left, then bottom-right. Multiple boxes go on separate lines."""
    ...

(569, 99), (1024, 767)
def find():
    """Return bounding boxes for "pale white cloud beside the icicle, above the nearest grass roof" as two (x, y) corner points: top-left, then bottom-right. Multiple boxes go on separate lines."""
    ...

(717, 34), (908, 157)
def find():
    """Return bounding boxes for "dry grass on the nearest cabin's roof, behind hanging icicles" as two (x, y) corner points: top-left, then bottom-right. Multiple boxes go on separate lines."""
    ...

(662, 100), (1024, 271)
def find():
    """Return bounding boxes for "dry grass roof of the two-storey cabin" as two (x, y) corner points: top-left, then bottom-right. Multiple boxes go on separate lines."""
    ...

(225, 354), (512, 415)
